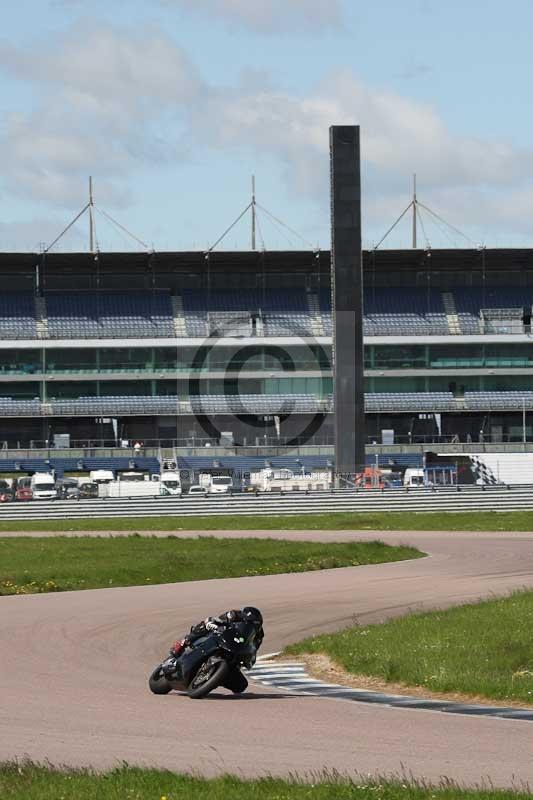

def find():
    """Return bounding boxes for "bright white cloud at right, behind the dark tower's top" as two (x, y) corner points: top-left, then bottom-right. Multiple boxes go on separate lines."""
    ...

(196, 72), (533, 191)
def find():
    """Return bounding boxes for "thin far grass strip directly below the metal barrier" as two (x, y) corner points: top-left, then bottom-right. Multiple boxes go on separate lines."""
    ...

(0, 511), (533, 535)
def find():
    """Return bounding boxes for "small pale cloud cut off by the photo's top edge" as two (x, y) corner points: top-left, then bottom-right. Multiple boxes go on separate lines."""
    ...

(160, 0), (341, 33)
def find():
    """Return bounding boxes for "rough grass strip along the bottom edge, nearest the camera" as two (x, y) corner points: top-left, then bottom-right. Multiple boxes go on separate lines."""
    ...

(0, 764), (533, 800)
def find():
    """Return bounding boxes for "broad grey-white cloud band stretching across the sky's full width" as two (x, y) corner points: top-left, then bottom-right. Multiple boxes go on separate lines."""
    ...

(0, 21), (533, 241)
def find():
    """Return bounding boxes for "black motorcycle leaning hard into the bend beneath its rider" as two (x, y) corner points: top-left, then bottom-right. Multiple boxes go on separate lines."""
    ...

(148, 621), (257, 698)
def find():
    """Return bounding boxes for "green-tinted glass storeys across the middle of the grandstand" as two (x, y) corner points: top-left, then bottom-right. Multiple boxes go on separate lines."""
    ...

(0, 341), (533, 399)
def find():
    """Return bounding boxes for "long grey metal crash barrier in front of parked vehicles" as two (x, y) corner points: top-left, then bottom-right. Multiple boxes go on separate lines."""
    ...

(0, 486), (533, 521)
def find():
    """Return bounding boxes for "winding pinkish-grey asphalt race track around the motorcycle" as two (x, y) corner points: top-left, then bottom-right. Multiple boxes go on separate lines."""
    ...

(0, 531), (533, 786)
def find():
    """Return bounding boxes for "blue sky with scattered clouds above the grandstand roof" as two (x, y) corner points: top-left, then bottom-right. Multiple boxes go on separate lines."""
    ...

(0, 0), (533, 251)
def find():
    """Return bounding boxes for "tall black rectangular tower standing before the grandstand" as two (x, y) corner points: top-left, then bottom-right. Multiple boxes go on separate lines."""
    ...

(329, 125), (365, 475)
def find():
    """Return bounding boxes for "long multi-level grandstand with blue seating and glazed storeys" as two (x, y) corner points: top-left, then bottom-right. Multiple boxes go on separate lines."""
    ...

(0, 249), (533, 448)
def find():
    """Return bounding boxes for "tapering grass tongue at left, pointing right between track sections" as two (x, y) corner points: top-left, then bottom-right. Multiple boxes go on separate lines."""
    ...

(0, 535), (424, 594)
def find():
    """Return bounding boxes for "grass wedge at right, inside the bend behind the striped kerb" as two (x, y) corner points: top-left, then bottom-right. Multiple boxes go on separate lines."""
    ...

(287, 591), (533, 704)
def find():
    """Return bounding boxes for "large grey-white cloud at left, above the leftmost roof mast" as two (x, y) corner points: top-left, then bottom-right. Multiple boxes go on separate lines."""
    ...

(0, 25), (203, 204)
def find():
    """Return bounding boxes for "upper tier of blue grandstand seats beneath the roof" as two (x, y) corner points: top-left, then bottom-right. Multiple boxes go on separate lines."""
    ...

(0, 288), (533, 339)
